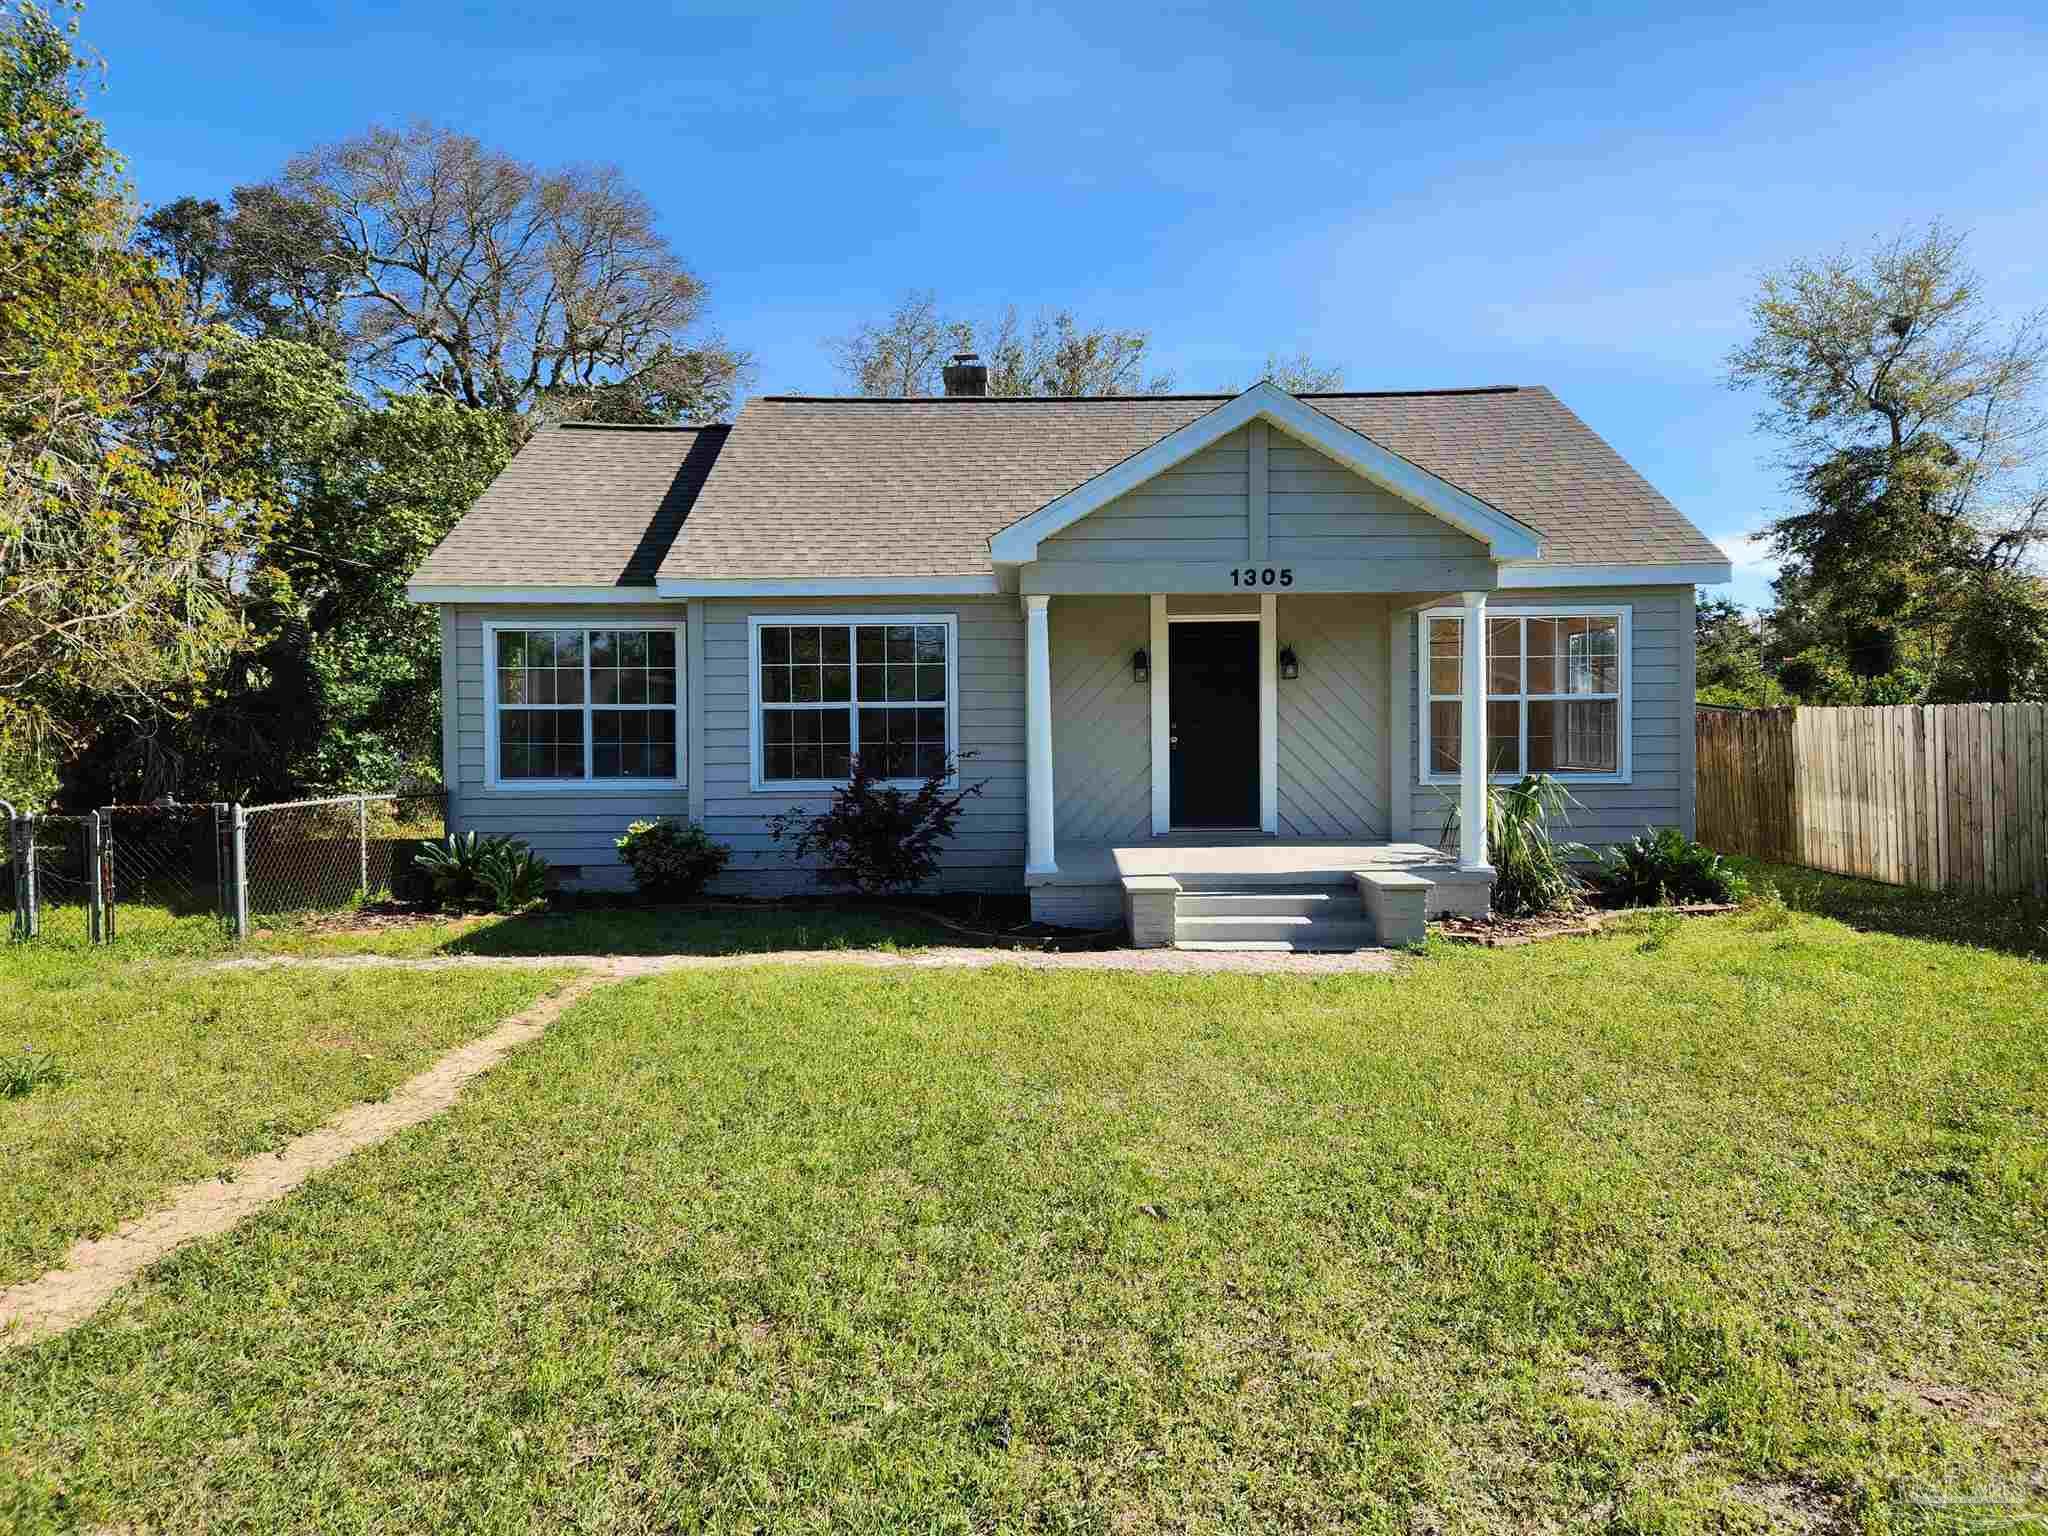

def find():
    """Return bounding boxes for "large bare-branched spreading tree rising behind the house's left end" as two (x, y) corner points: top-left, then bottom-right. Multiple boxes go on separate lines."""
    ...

(190, 123), (748, 420)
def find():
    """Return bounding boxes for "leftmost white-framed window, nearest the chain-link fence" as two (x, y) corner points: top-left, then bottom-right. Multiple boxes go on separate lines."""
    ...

(485, 625), (682, 788)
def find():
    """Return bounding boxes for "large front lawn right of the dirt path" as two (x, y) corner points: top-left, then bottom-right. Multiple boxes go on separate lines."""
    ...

(0, 909), (2048, 1532)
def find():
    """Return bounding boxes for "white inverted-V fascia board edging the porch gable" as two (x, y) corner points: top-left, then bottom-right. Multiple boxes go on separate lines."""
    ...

(989, 379), (1542, 565)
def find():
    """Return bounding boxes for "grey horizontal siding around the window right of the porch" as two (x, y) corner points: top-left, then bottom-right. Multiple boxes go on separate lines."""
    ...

(1395, 586), (1694, 846)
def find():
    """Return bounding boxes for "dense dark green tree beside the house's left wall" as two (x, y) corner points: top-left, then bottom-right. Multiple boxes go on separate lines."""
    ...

(72, 328), (516, 799)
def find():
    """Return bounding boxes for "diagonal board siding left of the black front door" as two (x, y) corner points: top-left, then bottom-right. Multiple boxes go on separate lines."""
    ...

(1049, 598), (1151, 850)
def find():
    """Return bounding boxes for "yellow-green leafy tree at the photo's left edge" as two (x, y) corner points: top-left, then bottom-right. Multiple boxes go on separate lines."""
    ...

(0, 0), (264, 806)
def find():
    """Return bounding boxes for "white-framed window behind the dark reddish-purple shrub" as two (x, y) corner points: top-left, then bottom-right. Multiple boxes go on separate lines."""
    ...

(752, 616), (956, 788)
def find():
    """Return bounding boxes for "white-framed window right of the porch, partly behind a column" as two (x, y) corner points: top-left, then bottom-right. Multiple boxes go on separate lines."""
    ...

(1421, 608), (1628, 780)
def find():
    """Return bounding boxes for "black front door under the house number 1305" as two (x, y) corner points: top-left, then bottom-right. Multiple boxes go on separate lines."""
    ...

(1167, 623), (1260, 827)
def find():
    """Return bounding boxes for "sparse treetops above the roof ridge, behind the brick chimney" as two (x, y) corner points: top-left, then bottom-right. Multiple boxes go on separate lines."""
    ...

(827, 289), (1174, 397)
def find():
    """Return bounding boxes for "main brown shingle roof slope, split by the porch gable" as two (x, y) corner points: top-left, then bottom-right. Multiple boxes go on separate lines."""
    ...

(662, 387), (1726, 582)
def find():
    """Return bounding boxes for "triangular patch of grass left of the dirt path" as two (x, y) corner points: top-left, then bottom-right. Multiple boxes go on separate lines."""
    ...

(0, 938), (573, 1284)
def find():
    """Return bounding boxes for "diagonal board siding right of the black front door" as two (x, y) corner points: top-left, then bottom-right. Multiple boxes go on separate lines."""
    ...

(1276, 596), (1386, 840)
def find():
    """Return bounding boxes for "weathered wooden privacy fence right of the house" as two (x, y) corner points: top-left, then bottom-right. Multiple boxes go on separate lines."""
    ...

(1698, 705), (2048, 895)
